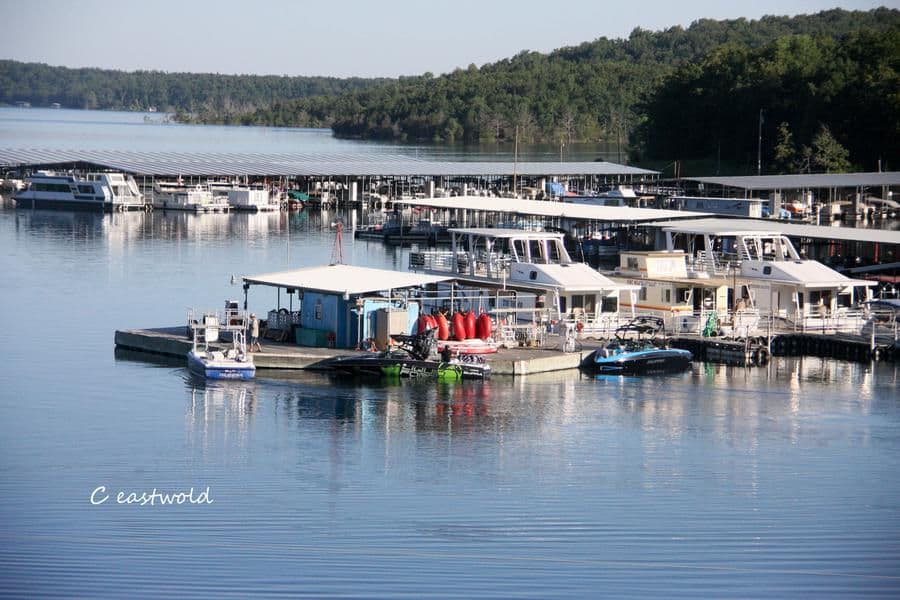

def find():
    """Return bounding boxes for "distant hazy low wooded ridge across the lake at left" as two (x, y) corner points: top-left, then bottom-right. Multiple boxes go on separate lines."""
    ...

(0, 60), (389, 115)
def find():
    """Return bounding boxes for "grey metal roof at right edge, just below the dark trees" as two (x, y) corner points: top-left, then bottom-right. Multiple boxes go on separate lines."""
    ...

(686, 171), (900, 190)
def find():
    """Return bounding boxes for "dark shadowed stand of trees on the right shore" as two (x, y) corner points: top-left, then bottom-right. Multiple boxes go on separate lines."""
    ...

(632, 27), (900, 173)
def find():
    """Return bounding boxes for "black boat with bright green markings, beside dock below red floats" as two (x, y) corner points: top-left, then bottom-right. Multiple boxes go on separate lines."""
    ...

(326, 330), (491, 381)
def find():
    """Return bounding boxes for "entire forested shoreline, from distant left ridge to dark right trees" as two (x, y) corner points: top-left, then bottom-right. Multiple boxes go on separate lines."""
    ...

(0, 8), (900, 173)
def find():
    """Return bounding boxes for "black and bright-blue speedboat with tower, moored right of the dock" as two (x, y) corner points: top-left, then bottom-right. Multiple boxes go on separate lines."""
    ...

(579, 317), (693, 375)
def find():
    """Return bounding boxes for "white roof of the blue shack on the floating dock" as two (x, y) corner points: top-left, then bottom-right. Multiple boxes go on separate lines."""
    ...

(242, 264), (450, 296)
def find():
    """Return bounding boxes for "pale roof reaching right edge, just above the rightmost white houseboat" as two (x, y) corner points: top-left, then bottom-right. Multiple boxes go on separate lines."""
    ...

(648, 219), (900, 244)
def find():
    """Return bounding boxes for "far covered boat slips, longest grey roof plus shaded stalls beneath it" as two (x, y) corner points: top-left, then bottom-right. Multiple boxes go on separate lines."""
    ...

(0, 148), (659, 209)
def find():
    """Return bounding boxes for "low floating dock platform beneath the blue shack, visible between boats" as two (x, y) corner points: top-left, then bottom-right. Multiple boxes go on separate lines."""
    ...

(115, 327), (590, 376)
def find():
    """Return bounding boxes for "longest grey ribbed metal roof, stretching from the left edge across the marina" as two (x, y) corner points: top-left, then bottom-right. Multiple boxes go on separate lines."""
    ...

(0, 148), (658, 177)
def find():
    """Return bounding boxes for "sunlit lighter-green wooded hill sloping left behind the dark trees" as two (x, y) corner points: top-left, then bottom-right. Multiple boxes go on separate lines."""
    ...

(234, 8), (900, 155)
